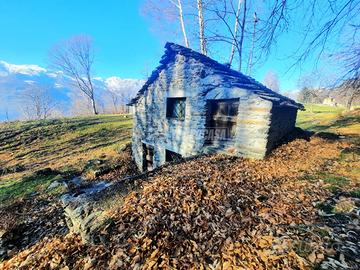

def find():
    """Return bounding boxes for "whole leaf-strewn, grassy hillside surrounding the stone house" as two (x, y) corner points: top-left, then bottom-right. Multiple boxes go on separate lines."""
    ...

(0, 105), (360, 269)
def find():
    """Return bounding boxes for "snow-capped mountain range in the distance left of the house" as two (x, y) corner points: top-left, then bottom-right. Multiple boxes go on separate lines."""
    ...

(0, 61), (144, 121)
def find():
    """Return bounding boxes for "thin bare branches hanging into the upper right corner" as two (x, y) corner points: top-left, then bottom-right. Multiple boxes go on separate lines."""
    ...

(293, 0), (360, 109)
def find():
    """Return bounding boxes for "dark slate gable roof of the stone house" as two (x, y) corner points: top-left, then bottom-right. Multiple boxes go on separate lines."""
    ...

(128, 42), (304, 109)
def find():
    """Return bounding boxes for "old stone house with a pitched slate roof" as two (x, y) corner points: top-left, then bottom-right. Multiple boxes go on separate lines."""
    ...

(129, 43), (303, 171)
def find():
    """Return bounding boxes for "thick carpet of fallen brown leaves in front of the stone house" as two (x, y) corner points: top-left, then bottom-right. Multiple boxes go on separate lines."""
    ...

(4, 137), (358, 269)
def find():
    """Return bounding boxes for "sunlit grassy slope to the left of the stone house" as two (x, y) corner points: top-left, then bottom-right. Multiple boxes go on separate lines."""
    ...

(0, 115), (132, 203)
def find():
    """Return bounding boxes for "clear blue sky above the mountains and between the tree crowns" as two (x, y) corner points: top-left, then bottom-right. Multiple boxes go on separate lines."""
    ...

(0, 0), (344, 91)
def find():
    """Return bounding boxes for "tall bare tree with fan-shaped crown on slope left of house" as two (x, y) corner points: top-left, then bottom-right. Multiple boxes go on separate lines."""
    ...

(49, 35), (98, 114)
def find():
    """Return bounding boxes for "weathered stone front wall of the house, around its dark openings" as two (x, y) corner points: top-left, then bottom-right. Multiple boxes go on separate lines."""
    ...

(132, 54), (298, 169)
